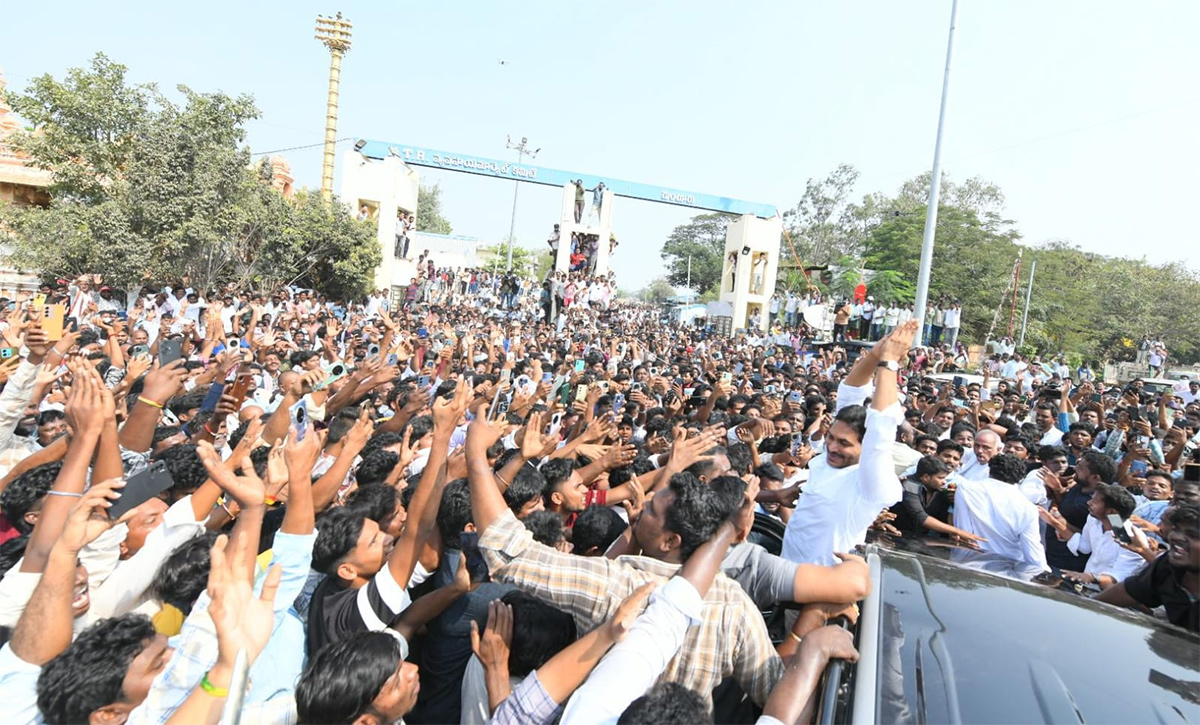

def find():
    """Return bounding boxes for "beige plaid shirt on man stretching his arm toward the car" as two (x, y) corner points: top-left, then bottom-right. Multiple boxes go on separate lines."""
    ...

(479, 510), (784, 706)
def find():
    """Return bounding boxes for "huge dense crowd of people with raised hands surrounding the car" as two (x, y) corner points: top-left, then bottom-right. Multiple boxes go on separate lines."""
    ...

(0, 268), (1200, 724)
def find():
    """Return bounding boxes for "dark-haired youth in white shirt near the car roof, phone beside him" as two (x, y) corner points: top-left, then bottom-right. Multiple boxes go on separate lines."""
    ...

(1040, 484), (1147, 589)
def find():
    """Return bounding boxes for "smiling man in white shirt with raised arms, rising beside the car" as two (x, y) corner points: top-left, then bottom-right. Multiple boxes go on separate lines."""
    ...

(782, 322), (917, 565)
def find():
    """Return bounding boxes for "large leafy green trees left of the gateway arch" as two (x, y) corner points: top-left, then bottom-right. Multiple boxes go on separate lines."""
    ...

(0, 54), (380, 296)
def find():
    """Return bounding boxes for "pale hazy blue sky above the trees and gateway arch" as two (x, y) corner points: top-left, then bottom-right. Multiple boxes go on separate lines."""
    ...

(0, 0), (1200, 289)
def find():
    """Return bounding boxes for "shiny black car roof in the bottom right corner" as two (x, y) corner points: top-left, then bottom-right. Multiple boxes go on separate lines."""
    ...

(854, 546), (1200, 723)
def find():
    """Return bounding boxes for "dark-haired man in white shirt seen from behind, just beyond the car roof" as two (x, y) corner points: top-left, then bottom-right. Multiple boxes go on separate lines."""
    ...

(950, 454), (1049, 571)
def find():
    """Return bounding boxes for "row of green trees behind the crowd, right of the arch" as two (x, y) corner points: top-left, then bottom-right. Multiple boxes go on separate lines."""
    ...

(768, 166), (1200, 363)
